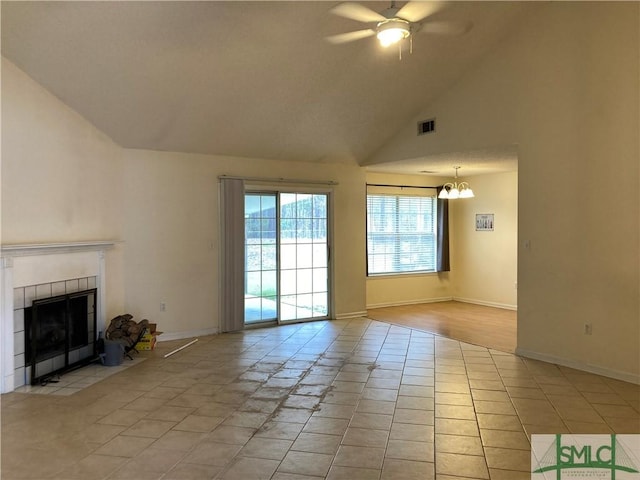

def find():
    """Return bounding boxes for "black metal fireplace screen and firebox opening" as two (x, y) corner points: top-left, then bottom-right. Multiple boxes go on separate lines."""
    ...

(25, 288), (97, 385)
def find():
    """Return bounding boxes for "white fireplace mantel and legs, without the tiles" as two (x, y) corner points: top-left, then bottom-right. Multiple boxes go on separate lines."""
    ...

(0, 240), (117, 393)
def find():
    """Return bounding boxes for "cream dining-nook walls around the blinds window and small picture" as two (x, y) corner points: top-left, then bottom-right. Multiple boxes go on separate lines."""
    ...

(367, 172), (518, 309)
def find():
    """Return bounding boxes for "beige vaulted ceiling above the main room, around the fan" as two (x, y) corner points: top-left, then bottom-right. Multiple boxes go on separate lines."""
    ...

(2, 1), (535, 174)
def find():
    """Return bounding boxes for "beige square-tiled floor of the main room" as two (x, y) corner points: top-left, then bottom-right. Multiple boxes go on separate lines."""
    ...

(0, 319), (640, 480)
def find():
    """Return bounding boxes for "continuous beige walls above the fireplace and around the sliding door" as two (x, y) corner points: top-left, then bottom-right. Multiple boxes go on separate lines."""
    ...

(1, 59), (365, 338)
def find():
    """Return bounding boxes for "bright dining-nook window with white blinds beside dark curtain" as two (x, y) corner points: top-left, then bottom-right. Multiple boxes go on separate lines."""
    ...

(367, 193), (437, 275)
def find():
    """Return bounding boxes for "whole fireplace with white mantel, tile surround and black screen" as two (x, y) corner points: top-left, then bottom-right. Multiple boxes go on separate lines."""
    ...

(0, 241), (115, 393)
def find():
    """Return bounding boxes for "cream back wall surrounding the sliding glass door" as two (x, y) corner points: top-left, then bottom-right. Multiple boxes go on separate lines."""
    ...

(124, 150), (365, 337)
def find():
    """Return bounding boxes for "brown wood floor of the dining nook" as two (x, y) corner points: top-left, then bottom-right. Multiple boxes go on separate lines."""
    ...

(367, 301), (517, 353)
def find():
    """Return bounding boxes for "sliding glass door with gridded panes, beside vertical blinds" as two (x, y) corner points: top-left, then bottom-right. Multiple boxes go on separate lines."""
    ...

(245, 192), (330, 324)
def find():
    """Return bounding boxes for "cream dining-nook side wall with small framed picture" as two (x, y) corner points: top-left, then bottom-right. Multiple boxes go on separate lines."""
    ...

(449, 172), (518, 309)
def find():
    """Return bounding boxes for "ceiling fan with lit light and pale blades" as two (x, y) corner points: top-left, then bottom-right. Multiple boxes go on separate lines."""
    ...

(327, 1), (471, 52)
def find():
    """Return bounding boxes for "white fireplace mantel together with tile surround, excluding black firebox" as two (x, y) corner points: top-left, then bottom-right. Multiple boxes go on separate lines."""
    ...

(0, 241), (114, 393)
